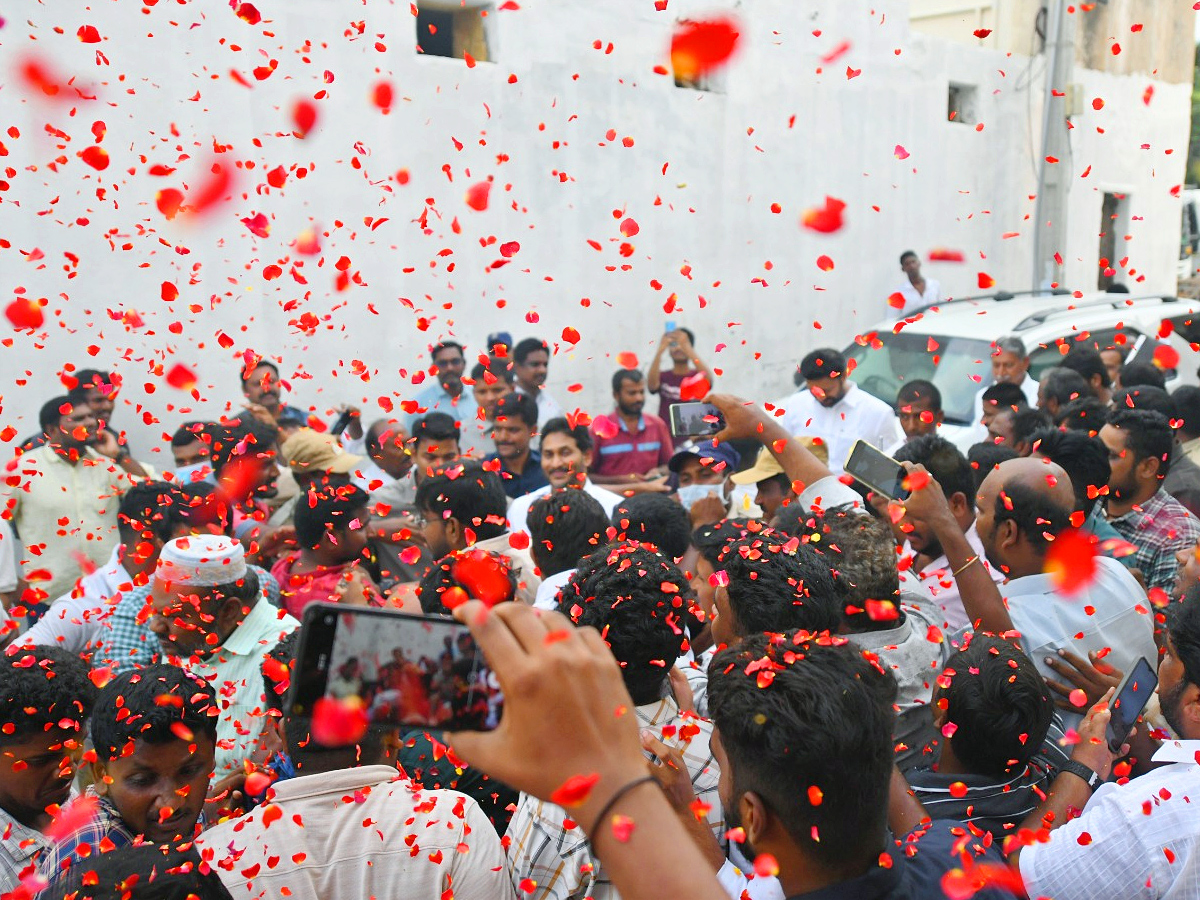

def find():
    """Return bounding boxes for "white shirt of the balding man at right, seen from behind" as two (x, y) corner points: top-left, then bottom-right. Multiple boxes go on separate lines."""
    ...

(1000, 557), (1158, 726)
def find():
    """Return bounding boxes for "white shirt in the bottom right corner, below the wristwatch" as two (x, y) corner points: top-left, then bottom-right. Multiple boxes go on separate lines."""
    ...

(1020, 740), (1200, 900)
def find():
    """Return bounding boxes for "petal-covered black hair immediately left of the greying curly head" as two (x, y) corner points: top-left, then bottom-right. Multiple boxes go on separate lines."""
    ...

(718, 532), (844, 637)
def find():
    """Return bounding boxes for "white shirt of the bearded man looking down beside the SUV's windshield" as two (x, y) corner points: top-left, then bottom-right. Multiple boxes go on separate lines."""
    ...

(775, 382), (902, 475)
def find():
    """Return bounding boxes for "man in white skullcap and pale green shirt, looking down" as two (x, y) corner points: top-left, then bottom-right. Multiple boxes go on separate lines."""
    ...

(113, 534), (300, 779)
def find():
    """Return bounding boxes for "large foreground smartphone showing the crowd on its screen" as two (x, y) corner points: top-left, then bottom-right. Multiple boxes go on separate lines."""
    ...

(287, 604), (504, 731)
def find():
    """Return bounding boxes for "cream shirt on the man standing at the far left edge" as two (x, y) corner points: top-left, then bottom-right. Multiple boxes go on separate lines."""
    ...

(0, 444), (132, 598)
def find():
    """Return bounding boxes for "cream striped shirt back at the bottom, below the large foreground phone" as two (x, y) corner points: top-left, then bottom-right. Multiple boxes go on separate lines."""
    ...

(196, 766), (514, 900)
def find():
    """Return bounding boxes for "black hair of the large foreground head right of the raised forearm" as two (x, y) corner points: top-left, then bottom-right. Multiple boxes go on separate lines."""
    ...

(708, 635), (896, 872)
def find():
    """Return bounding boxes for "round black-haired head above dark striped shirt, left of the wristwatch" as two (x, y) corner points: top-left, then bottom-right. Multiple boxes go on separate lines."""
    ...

(934, 632), (1054, 778)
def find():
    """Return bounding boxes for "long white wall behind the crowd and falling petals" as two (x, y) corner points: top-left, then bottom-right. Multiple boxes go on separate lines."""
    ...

(0, 0), (1190, 460)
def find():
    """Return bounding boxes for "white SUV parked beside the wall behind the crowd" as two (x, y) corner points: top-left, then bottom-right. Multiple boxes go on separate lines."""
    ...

(844, 290), (1200, 451)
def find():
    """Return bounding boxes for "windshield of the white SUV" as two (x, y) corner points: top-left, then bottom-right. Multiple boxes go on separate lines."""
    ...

(845, 332), (991, 425)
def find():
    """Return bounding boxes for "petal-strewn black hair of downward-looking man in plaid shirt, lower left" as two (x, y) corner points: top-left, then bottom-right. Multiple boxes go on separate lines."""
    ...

(91, 664), (220, 762)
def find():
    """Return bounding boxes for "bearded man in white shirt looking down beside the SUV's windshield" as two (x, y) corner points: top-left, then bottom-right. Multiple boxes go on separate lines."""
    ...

(775, 347), (900, 475)
